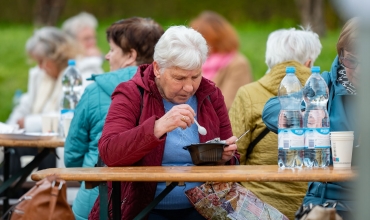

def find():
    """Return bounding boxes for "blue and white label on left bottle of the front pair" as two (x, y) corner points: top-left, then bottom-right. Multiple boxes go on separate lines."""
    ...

(278, 128), (304, 150)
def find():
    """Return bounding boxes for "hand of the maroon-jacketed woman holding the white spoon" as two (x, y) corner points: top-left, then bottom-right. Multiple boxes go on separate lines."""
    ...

(154, 104), (195, 138)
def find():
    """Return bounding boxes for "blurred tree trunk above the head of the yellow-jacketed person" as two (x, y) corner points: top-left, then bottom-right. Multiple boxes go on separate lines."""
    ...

(295, 0), (326, 36)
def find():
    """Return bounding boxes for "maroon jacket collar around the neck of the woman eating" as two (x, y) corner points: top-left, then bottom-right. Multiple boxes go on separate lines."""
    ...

(132, 64), (216, 102)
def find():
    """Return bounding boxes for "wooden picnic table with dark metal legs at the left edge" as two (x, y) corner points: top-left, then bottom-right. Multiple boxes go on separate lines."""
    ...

(0, 137), (64, 213)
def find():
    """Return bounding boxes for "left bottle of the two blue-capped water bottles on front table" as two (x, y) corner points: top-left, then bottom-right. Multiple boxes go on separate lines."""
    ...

(278, 67), (304, 168)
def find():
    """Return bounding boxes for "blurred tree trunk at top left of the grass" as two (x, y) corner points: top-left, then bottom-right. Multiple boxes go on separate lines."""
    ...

(34, 0), (67, 27)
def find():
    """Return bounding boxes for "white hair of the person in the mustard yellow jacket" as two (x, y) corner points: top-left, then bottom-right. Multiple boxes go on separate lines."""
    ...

(265, 27), (322, 72)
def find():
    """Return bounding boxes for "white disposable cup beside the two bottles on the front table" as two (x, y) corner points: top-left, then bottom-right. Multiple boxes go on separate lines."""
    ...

(330, 131), (353, 168)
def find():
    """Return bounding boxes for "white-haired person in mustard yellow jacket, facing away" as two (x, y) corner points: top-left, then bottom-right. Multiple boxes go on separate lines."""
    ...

(229, 28), (322, 219)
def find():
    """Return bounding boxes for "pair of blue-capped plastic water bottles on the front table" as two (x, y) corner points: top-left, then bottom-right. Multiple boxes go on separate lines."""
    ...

(278, 67), (330, 168)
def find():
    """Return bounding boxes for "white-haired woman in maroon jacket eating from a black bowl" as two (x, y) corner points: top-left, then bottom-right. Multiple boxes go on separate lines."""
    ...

(90, 26), (238, 219)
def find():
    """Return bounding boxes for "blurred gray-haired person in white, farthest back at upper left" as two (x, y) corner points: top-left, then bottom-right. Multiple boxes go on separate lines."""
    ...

(62, 12), (104, 89)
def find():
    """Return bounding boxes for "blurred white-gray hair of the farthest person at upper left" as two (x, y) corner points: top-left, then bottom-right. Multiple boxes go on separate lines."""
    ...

(62, 12), (98, 38)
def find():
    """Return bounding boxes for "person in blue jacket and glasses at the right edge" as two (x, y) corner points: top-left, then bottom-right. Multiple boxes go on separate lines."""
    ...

(262, 18), (360, 219)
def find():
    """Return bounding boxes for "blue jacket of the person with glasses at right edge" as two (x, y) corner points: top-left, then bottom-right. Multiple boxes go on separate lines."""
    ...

(262, 57), (360, 219)
